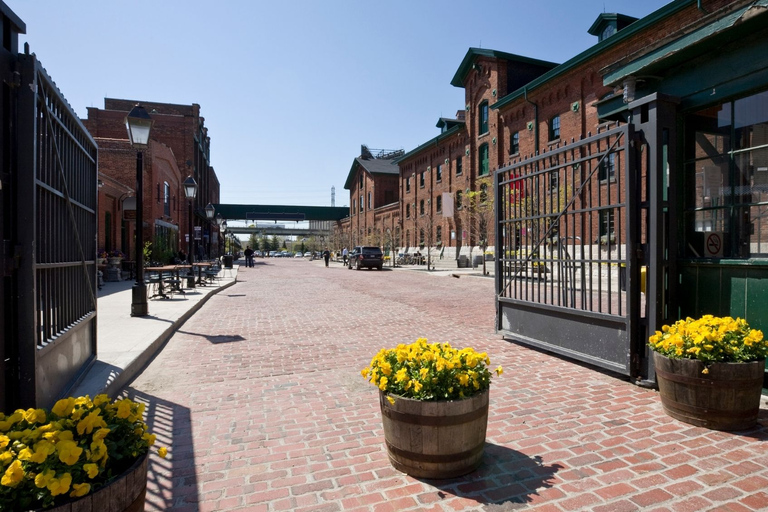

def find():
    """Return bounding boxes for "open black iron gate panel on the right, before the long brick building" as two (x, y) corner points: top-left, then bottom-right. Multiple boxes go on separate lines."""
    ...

(495, 124), (644, 375)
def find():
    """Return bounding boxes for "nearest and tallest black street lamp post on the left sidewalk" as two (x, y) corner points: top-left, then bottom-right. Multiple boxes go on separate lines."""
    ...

(125, 103), (153, 316)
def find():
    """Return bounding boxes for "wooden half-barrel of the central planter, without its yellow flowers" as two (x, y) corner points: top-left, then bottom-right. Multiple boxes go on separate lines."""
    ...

(379, 391), (489, 479)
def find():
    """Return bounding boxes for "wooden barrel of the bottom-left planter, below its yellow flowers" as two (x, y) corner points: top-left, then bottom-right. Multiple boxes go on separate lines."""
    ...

(45, 455), (149, 512)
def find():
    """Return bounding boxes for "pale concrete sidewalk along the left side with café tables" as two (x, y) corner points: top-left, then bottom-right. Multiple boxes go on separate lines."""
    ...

(72, 264), (239, 397)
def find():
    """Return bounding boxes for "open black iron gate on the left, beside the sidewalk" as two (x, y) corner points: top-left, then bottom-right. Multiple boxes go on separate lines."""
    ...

(2, 47), (98, 409)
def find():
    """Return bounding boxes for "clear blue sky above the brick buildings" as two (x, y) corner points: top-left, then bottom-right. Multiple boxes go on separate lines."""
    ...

(10, 0), (668, 206)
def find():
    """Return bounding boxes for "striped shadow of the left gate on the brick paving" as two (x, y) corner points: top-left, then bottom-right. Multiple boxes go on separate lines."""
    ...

(122, 387), (200, 511)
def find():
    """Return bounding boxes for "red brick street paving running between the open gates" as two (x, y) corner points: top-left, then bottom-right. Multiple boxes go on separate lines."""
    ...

(126, 259), (768, 512)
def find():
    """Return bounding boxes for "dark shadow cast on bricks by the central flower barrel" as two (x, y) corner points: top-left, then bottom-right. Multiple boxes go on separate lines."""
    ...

(424, 442), (563, 512)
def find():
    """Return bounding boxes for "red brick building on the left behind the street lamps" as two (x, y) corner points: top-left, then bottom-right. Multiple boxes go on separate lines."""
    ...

(83, 98), (220, 261)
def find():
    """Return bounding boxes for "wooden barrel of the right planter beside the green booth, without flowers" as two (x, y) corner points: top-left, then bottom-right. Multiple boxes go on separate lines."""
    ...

(653, 352), (765, 430)
